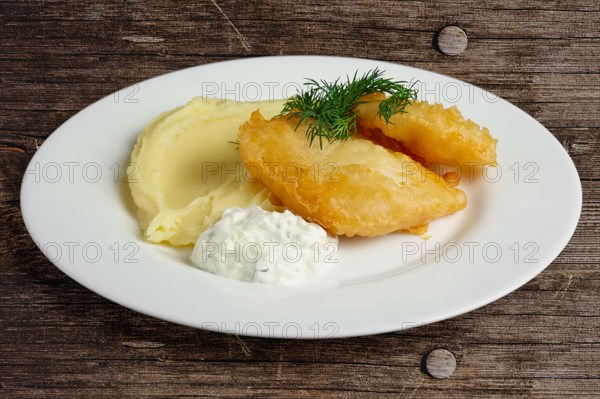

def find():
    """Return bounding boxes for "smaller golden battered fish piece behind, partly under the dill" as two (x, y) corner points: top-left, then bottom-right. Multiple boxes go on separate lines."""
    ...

(355, 93), (497, 166)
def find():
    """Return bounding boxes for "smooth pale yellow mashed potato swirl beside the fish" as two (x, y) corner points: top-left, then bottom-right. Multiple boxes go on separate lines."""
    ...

(129, 97), (283, 245)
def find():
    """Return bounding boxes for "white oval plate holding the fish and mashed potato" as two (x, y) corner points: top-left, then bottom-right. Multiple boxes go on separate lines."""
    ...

(21, 56), (581, 338)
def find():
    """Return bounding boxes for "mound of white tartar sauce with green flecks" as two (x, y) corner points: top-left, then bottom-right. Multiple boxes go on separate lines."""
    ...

(191, 205), (338, 284)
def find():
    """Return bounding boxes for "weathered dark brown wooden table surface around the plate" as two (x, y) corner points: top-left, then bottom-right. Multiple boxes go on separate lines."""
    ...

(0, 0), (600, 399)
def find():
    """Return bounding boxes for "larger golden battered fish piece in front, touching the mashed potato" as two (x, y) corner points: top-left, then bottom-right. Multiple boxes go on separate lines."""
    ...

(238, 111), (467, 237)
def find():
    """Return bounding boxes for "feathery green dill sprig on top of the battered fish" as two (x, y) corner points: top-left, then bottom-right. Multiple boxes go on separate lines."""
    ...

(280, 68), (417, 148)
